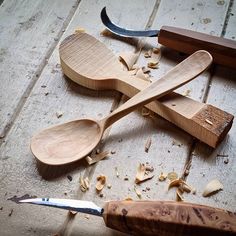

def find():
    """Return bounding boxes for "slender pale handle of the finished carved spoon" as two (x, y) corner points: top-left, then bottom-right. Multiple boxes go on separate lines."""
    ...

(101, 50), (212, 129)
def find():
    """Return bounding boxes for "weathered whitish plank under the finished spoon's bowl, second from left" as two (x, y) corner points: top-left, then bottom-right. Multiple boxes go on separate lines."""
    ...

(0, 1), (157, 235)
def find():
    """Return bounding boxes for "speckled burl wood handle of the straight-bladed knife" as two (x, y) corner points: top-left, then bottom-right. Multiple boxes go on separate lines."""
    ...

(103, 201), (236, 236)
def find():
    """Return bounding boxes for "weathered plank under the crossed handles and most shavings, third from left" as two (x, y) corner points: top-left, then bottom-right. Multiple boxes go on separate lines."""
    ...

(75, 1), (232, 230)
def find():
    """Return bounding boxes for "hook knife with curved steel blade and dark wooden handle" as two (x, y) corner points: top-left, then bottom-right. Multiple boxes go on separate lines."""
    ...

(101, 7), (236, 69)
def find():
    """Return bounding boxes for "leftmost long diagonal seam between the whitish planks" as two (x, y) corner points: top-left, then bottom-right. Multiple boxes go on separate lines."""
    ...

(0, 0), (81, 147)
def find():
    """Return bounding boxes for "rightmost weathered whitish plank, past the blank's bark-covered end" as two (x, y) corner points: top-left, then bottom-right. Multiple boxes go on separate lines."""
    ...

(186, 2), (236, 212)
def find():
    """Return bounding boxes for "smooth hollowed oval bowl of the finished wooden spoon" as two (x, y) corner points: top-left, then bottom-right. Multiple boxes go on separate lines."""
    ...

(31, 119), (103, 165)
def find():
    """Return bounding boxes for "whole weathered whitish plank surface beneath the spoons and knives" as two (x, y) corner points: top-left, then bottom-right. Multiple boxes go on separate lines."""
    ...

(0, 0), (236, 236)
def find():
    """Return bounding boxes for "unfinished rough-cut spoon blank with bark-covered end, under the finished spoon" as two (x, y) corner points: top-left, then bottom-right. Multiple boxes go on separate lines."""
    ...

(59, 34), (233, 147)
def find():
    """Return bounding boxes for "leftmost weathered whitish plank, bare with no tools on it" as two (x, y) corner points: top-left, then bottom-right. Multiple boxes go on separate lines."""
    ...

(0, 0), (78, 137)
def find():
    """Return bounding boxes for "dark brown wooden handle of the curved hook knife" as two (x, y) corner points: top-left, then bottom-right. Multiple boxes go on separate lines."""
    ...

(158, 26), (236, 69)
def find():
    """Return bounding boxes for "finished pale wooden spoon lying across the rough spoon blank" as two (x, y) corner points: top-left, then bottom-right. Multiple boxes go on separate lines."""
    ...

(31, 50), (212, 165)
